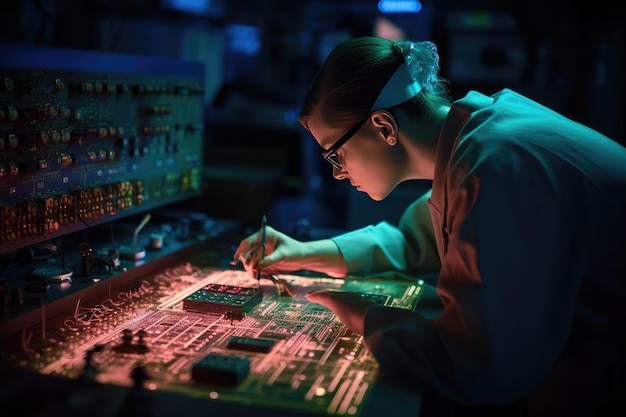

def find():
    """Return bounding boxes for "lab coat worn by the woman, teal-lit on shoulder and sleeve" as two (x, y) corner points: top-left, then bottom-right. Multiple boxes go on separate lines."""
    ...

(334, 89), (626, 416)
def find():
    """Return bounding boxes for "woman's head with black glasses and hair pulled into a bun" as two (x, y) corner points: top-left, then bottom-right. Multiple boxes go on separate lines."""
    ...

(300, 37), (450, 200)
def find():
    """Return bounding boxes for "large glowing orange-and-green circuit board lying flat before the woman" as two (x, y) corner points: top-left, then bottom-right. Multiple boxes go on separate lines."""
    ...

(2, 263), (421, 416)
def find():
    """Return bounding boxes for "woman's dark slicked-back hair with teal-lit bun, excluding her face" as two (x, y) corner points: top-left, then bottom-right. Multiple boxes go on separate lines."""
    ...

(300, 36), (449, 128)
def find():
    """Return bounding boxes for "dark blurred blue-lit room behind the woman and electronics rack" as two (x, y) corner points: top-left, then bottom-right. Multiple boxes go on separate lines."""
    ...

(0, 0), (626, 232)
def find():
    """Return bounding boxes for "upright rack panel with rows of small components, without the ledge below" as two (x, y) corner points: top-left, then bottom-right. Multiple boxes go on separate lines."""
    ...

(0, 45), (204, 253)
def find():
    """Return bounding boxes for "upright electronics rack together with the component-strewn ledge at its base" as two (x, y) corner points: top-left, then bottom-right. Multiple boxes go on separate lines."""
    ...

(0, 44), (233, 348)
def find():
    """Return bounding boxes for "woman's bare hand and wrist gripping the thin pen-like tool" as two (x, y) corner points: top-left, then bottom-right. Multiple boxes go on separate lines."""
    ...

(233, 226), (346, 277)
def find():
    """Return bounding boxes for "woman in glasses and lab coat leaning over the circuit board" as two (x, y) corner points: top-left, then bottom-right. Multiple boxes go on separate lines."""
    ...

(234, 37), (626, 417)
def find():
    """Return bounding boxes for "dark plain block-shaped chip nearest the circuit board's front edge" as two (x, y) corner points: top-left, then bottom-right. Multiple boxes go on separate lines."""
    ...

(191, 352), (250, 385)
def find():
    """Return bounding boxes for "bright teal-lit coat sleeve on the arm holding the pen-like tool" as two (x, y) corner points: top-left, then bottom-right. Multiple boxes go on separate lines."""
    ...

(332, 191), (441, 276)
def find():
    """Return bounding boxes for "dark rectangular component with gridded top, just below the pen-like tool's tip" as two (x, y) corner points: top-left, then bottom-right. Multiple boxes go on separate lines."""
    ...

(183, 284), (263, 319)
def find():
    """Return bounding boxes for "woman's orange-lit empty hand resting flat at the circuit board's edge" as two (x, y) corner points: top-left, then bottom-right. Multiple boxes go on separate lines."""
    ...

(306, 289), (376, 335)
